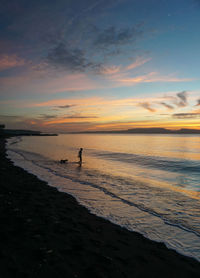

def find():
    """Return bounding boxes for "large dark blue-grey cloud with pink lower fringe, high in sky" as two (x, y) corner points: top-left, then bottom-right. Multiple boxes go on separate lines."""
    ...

(46, 24), (144, 74)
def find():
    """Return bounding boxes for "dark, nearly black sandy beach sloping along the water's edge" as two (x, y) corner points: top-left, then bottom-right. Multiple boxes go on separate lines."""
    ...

(0, 138), (200, 278)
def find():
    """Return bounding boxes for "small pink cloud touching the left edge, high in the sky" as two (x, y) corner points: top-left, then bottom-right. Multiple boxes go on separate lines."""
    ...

(0, 55), (25, 71)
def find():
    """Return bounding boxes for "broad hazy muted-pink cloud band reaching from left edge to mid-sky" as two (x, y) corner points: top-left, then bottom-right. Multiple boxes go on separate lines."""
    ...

(0, 69), (103, 96)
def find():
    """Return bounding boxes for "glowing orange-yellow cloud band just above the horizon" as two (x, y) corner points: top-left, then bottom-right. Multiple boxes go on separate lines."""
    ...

(0, 110), (200, 132)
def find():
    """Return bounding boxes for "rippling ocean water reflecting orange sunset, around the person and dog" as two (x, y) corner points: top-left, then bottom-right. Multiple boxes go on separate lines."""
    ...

(7, 134), (200, 261)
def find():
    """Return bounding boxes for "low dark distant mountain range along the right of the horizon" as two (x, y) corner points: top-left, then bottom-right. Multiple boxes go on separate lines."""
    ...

(80, 128), (200, 134)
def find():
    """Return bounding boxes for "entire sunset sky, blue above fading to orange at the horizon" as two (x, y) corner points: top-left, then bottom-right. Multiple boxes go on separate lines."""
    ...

(0, 0), (200, 132)
